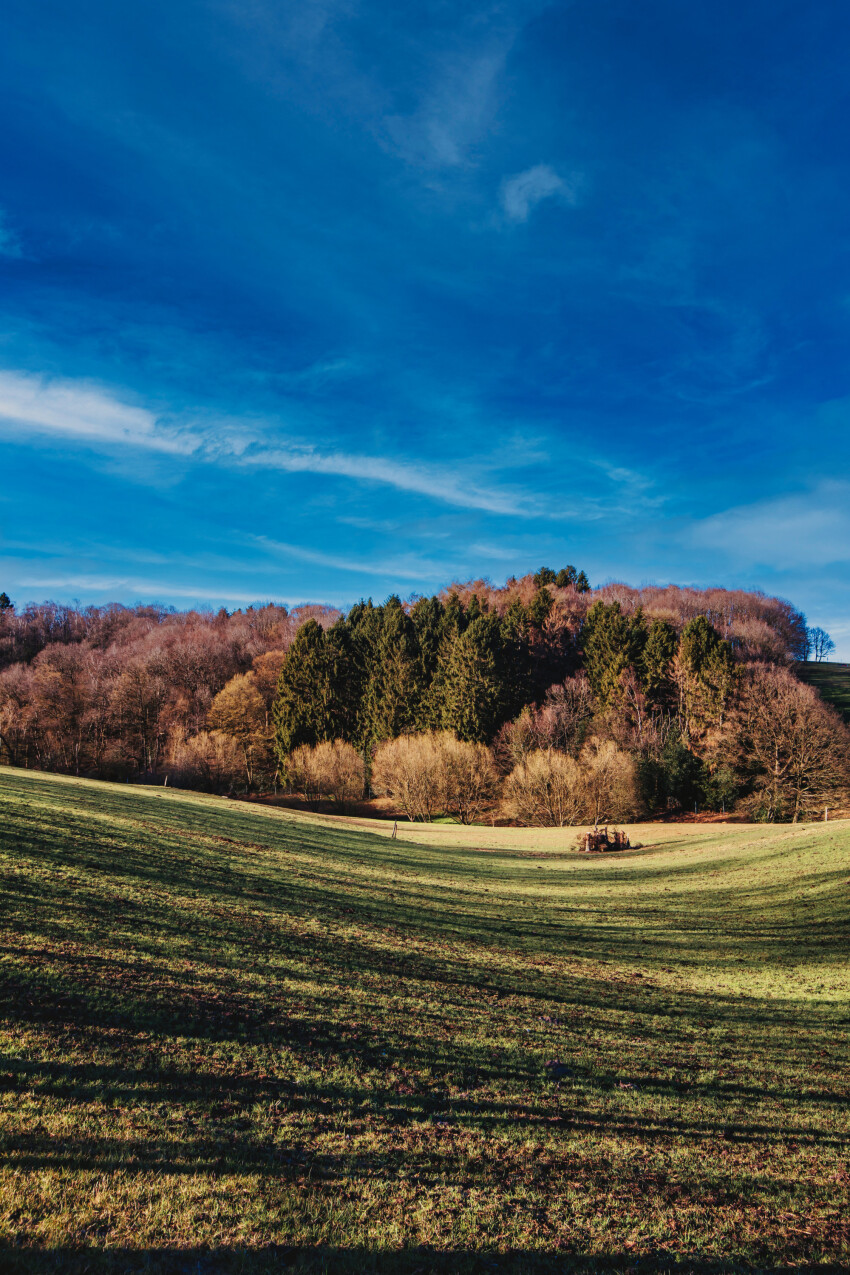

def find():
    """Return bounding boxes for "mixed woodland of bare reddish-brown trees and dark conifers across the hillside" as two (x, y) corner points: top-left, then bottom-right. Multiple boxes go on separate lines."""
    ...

(0, 567), (850, 825)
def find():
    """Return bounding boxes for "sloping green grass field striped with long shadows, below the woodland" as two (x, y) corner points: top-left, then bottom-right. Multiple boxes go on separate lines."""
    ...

(0, 770), (850, 1275)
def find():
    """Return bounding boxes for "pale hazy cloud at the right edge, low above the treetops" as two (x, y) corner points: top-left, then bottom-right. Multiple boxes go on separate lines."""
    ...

(691, 482), (850, 570)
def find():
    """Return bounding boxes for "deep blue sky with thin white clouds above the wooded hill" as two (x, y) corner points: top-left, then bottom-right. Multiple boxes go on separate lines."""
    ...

(0, 0), (850, 659)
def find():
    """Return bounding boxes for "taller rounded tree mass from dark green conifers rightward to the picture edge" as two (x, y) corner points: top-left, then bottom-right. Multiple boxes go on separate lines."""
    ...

(273, 586), (849, 825)
